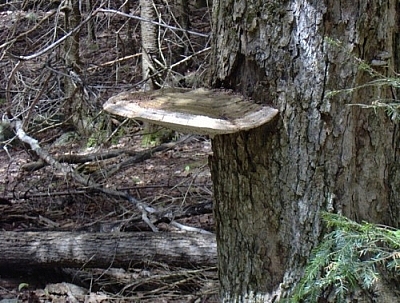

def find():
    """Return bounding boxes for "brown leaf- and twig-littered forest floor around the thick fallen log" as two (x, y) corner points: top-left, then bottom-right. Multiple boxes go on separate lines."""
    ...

(0, 131), (218, 302)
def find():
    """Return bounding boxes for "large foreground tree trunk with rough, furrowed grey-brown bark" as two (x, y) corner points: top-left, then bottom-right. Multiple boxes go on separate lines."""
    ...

(210, 0), (400, 302)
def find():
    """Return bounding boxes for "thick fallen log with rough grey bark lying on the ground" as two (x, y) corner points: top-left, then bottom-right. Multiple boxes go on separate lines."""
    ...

(0, 231), (217, 268)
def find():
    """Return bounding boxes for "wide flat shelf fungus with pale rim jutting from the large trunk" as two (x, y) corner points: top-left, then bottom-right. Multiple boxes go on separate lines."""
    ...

(103, 88), (278, 136)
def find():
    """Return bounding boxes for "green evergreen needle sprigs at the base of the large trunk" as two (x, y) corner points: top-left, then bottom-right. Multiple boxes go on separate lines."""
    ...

(290, 213), (400, 303)
